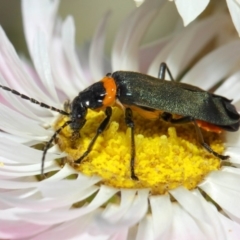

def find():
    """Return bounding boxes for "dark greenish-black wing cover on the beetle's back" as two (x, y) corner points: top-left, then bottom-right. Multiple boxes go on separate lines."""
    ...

(112, 71), (239, 131)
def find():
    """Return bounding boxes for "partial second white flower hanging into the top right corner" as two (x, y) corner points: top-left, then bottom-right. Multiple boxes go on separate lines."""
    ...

(170, 0), (240, 35)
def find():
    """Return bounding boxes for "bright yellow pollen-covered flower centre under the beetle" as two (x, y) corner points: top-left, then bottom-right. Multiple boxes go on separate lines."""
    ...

(54, 107), (224, 195)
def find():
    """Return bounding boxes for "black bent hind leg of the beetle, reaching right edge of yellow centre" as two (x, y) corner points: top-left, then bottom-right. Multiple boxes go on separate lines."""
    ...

(161, 112), (229, 160)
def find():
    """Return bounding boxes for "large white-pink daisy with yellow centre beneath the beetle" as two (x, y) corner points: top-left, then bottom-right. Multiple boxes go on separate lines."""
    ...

(0, 0), (240, 240)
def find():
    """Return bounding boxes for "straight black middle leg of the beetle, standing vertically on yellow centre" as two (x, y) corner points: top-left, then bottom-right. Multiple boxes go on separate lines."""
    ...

(125, 108), (138, 180)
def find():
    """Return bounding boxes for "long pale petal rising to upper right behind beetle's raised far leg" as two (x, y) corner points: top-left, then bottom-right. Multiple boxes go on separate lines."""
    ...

(148, 15), (225, 79)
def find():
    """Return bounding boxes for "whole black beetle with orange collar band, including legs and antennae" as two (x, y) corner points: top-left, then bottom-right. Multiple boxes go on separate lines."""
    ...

(0, 63), (240, 180)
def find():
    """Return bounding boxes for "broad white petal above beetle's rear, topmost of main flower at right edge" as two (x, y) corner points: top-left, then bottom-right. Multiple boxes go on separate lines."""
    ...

(182, 40), (240, 90)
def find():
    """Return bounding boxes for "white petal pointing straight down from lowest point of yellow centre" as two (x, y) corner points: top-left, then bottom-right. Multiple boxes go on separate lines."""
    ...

(150, 194), (173, 239)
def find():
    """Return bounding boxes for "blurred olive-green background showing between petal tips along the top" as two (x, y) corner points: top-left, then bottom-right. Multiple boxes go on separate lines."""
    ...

(0, 0), (182, 54)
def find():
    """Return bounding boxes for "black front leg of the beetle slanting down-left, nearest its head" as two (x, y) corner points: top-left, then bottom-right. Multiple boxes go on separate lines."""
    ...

(74, 107), (112, 165)
